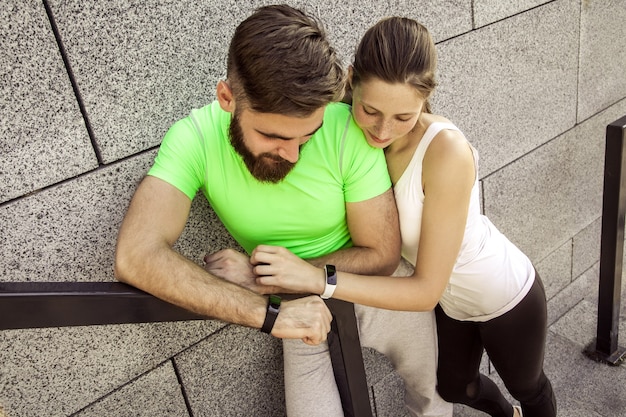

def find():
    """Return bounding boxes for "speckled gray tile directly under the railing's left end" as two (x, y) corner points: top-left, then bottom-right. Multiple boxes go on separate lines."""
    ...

(0, 320), (223, 417)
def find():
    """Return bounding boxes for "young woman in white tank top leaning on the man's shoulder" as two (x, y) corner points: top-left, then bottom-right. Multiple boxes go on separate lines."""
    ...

(246, 17), (556, 417)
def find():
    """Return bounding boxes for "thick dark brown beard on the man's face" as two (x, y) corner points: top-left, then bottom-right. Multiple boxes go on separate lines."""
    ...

(228, 112), (296, 183)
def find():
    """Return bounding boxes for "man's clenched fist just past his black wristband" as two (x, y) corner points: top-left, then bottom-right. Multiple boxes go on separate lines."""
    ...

(272, 295), (333, 345)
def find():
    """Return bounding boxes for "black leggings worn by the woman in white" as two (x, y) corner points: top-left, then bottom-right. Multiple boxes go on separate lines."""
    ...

(435, 275), (556, 417)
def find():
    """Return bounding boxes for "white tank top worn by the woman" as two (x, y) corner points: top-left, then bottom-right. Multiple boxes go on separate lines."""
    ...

(394, 122), (535, 321)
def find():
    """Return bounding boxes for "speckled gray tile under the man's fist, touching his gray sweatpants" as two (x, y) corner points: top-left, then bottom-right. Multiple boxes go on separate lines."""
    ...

(175, 326), (285, 417)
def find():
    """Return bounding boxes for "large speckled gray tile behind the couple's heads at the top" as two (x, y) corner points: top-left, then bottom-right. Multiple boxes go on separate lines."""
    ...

(50, 0), (471, 162)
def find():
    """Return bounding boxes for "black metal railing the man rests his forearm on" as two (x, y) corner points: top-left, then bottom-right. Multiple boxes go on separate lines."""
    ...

(0, 282), (372, 417)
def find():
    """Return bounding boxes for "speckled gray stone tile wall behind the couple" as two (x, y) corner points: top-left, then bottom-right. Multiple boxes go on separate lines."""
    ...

(0, 0), (626, 417)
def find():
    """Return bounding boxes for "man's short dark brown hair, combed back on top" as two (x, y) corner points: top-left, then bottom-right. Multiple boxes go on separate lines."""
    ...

(227, 5), (345, 116)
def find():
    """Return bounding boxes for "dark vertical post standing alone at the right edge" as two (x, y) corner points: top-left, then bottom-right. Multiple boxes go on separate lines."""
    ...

(586, 116), (626, 365)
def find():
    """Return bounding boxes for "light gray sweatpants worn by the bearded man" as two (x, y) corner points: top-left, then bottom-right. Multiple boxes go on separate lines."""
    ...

(283, 305), (452, 417)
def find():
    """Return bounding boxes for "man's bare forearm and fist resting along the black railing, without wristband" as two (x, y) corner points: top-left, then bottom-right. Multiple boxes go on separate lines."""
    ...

(116, 242), (332, 344)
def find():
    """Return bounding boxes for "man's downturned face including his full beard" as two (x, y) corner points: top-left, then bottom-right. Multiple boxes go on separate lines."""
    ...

(229, 107), (324, 183)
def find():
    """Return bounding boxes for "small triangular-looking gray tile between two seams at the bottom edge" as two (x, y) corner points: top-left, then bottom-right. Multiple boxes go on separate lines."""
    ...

(73, 361), (189, 417)
